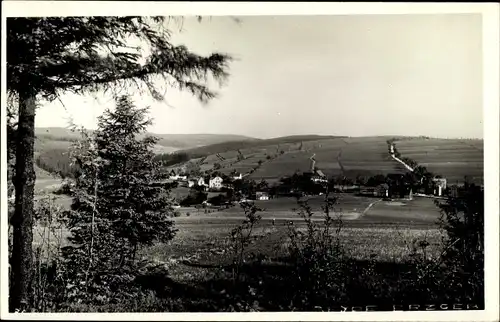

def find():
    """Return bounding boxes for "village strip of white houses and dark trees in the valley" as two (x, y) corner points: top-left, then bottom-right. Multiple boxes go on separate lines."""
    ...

(168, 151), (450, 207)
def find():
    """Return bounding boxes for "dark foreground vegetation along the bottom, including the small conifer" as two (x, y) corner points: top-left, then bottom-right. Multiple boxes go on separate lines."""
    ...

(7, 97), (484, 312)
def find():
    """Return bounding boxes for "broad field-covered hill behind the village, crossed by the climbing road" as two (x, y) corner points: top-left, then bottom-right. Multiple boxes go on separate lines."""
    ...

(170, 136), (483, 184)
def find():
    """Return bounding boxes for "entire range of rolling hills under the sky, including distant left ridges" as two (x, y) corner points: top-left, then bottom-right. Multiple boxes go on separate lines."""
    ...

(35, 128), (484, 184)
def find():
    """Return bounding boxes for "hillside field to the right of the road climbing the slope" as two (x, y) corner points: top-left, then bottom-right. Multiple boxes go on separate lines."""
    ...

(396, 139), (484, 185)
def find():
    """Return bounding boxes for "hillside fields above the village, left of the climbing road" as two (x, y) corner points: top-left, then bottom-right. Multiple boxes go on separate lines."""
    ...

(188, 137), (406, 181)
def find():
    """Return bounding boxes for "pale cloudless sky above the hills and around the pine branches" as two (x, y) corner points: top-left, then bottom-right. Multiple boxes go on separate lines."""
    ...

(36, 14), (483, 138)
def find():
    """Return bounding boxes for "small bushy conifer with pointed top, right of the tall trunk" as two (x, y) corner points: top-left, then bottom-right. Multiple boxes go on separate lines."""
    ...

(64, 97), (175, 299)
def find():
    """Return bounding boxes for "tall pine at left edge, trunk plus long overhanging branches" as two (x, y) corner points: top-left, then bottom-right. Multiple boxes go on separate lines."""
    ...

(6, 16), (230, 311)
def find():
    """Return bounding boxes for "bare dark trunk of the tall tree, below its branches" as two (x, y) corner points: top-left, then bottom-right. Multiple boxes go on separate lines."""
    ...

(9, 86), (36, 311)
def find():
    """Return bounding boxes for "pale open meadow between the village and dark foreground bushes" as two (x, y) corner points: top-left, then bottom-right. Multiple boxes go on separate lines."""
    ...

(35, 190), (440, 263)
